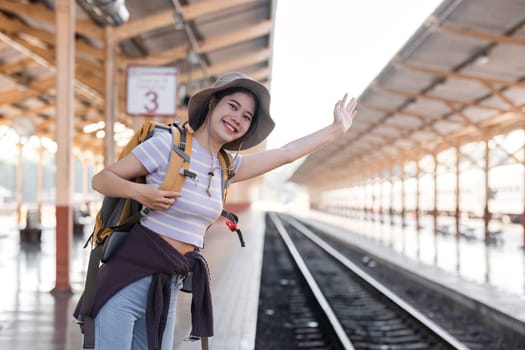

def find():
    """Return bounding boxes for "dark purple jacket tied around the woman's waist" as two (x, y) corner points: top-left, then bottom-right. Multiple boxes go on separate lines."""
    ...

(80, 224), (213, 349)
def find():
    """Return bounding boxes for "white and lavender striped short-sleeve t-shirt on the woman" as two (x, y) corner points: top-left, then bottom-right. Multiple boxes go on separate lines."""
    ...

(132, 131), (242, 248)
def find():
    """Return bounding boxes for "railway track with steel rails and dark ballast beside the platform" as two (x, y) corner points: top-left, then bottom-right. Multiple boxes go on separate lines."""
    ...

(256, 213), (520, 350)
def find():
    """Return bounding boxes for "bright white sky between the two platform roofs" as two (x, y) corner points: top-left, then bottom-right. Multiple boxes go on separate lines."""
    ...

(268, 0), (441, 148)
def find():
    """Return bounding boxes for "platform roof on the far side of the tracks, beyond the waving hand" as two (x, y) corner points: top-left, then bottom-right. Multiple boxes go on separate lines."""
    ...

(290, 0), (525, 191)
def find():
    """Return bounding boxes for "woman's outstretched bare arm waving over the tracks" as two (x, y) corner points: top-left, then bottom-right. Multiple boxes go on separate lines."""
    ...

(234, 94), (357, 182)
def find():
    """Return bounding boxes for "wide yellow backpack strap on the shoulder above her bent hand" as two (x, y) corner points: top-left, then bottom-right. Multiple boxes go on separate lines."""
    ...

(160, 123), (195, 192)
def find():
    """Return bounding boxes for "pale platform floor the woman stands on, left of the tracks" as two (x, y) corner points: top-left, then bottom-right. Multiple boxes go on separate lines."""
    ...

(0, 211), (264, 350)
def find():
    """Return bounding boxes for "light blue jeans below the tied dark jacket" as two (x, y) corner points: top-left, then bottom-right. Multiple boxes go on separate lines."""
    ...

(87, 275), (182, 350)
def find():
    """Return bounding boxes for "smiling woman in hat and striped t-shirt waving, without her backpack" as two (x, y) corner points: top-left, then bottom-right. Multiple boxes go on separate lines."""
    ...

(85, 72), (356, 350)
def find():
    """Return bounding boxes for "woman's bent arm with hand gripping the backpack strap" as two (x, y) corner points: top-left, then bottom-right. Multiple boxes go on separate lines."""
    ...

(92, 154), (180, 210)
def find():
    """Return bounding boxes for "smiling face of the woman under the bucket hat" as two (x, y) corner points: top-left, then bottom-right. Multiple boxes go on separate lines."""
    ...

(209, 92), (255, 145)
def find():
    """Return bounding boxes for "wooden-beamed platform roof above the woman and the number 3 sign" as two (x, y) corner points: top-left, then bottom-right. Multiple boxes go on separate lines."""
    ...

(0, 0), (275, 154)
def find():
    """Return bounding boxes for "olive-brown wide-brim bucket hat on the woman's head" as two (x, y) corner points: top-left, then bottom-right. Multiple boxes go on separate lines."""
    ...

(188, 72), (275, 151)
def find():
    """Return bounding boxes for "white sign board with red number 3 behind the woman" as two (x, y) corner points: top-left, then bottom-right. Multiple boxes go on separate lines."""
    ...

(126, 66), (177, 115)
